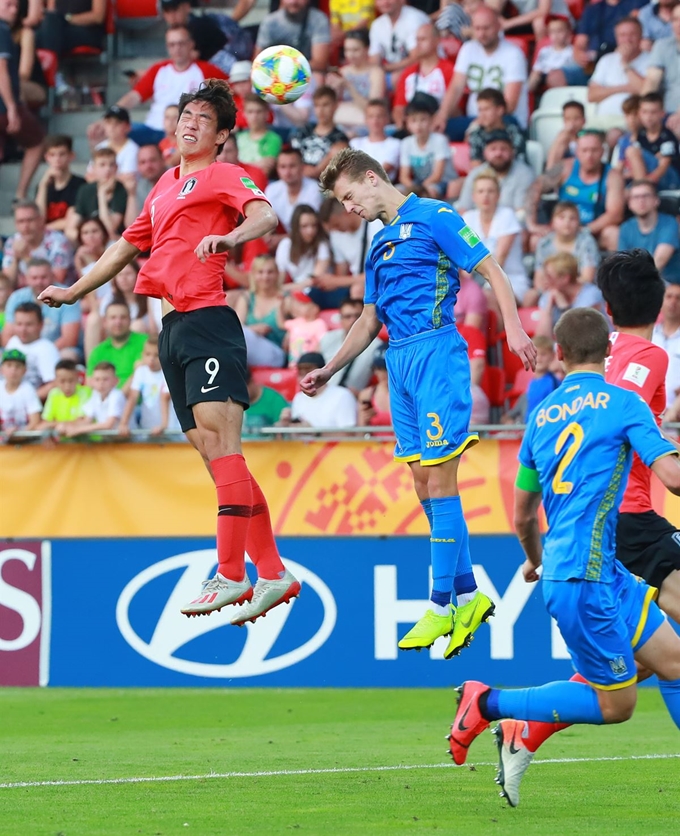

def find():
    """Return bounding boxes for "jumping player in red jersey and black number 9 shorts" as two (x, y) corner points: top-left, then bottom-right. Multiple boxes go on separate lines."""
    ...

(40, 79), (300, 626)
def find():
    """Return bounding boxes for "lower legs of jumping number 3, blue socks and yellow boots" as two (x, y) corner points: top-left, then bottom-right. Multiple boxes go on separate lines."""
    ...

(399, 456), (494, 659)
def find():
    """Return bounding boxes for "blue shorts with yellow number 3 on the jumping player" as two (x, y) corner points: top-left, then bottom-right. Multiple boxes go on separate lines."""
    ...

(385, 325), (479, 465)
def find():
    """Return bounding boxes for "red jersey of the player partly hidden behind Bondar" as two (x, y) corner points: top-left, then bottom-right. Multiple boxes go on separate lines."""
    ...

(605, 331), (668, 514)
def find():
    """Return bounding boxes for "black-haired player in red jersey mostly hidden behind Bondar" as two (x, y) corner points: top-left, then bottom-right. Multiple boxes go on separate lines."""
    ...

(484, 250), (680, 807)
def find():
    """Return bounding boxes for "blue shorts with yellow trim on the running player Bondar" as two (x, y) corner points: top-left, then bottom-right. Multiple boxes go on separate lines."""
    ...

(543, 562), (664, 691)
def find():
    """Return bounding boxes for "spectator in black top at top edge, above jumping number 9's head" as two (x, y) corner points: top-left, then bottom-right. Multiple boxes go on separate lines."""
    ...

(161, 0), (253, 74)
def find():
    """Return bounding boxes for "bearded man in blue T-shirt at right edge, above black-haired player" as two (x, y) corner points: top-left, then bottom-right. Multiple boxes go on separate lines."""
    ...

(619, 180), (680, 284)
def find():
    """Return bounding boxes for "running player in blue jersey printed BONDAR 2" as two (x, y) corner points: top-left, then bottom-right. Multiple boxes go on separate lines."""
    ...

(449, 308), (680, 796)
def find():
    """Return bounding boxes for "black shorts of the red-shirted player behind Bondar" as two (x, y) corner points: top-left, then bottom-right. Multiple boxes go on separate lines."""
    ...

(616, 511), (680, 589)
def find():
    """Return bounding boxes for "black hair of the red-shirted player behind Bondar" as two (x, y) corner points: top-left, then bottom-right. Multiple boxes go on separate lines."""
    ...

(597, 249), (666, 328)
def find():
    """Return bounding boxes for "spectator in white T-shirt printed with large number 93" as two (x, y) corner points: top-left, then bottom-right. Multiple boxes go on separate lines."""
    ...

(434, 6), (529, 141)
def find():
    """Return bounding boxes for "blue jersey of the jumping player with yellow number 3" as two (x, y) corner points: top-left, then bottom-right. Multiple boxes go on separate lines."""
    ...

(364, 194), (489, 340)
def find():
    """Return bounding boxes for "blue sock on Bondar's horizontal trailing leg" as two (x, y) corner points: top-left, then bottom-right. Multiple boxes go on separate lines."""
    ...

(484, 682), (604, 726)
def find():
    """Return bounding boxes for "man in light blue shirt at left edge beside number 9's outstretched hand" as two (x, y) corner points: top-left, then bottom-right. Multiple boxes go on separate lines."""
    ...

(2, 258), (81, 360)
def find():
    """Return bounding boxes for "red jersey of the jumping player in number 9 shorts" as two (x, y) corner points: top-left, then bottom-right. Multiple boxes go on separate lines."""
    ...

(123, 162), (269, 311)
